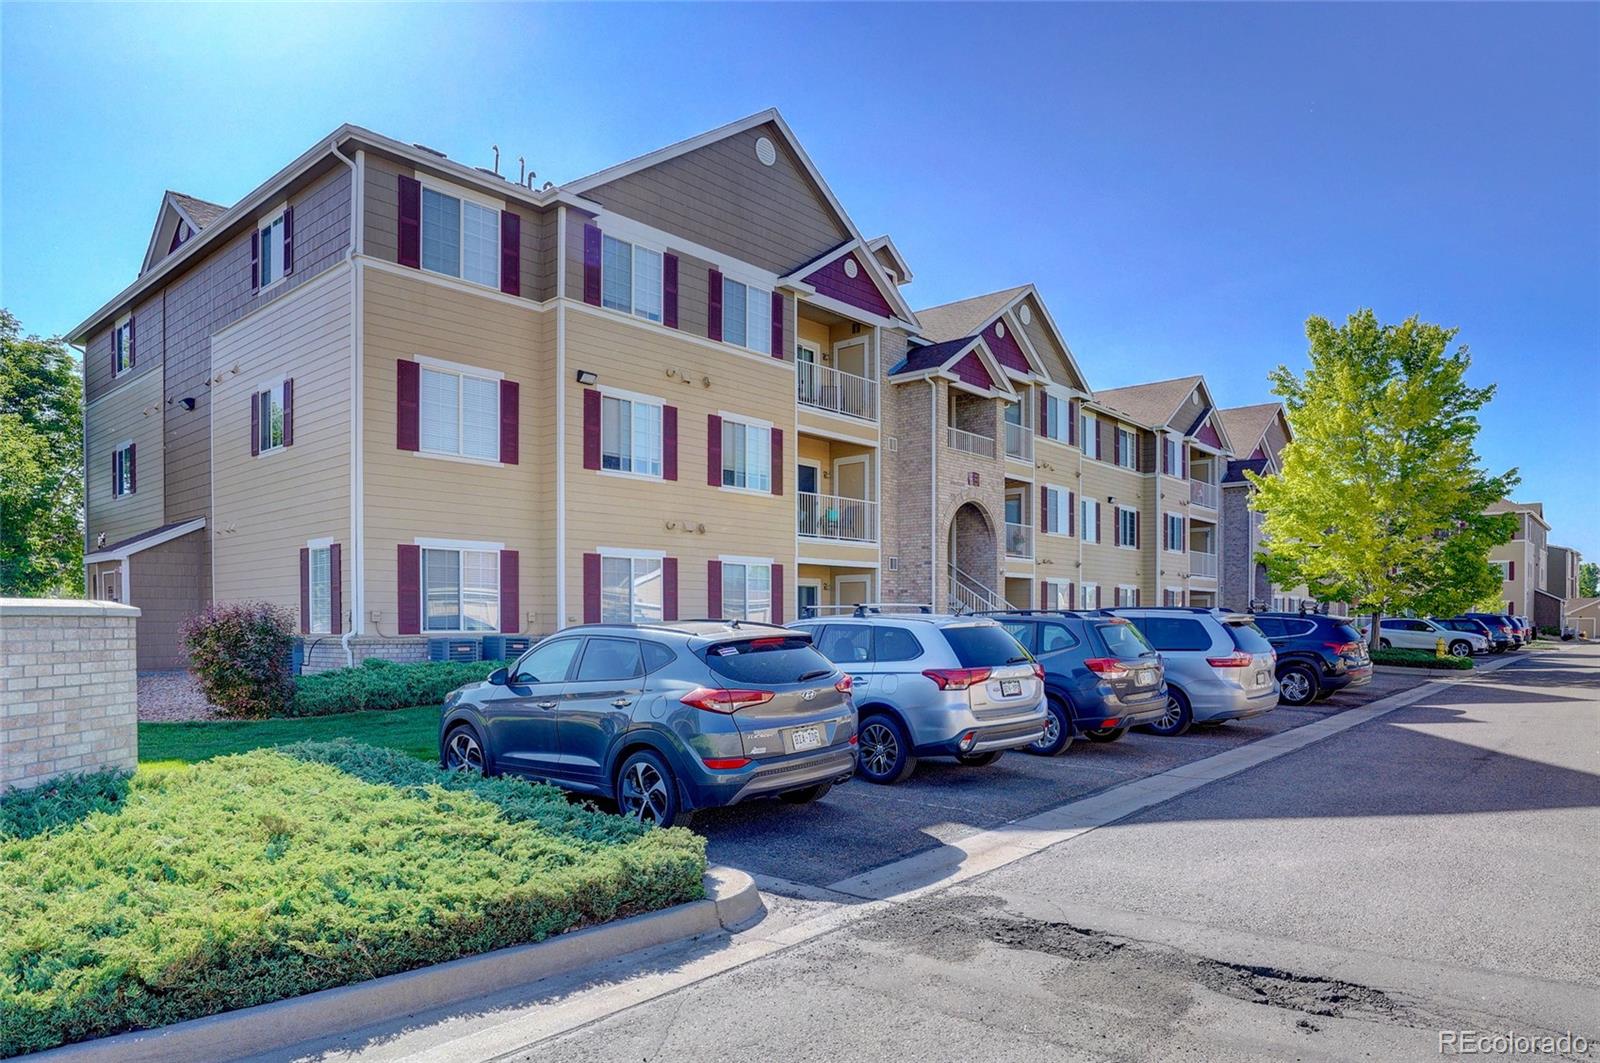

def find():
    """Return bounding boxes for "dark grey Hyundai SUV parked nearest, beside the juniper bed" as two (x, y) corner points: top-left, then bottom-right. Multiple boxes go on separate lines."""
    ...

(438, 620), (856, 826)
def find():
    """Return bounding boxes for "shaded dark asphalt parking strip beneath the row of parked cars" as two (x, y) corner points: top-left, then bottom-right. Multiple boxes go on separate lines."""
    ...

(694, 669), (1448, 895)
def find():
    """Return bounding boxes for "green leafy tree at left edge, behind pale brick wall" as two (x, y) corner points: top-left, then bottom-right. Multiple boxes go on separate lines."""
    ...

(0, 311), (83, 597)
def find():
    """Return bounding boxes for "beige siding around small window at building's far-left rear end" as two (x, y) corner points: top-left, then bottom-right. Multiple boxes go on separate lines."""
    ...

(85, 371), (165, 551)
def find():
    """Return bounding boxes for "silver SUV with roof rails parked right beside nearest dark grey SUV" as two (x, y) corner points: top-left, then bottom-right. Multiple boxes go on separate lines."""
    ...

(790, 605), (1046, 783)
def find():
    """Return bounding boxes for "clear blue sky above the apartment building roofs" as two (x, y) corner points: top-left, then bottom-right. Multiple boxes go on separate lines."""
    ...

(0, 3), (1600, 559)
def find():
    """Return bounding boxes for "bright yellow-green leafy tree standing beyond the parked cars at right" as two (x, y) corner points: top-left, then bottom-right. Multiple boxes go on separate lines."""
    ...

(1250, 302), (1520, 645)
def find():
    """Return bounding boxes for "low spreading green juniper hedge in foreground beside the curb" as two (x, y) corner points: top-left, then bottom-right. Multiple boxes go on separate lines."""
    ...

(0, 748), (706, 1057)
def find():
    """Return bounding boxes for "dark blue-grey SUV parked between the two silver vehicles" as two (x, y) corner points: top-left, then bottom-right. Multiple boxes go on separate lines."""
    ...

(984, 610), (1166, 757)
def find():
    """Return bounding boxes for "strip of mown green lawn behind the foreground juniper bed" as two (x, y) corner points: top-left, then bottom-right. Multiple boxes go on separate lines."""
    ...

(139, 704), (438, 768)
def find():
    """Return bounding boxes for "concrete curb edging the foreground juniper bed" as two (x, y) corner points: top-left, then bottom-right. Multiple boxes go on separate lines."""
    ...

(27, 868), (766, 1063)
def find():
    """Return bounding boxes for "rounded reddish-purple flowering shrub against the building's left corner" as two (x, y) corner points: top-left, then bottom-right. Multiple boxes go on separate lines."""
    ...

(184, 602), (294, 719)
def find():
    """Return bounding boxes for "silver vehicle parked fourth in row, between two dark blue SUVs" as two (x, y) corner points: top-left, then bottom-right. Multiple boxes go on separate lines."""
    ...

(1099, 605), (1278, 735)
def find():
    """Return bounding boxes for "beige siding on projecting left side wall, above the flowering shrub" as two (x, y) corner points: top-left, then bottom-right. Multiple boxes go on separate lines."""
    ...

(210, 267), (354, 623)
